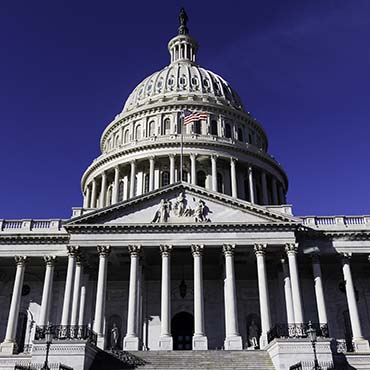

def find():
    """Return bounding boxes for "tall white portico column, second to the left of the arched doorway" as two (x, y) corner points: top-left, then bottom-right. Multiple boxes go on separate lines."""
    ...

(123, 245), (141, 351)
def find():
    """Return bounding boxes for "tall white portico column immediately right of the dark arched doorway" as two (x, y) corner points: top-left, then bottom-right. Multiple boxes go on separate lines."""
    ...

(191, 244), (208, 350)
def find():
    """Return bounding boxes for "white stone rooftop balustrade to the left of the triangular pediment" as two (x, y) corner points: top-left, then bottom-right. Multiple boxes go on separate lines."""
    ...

(0, 220), (64, 234)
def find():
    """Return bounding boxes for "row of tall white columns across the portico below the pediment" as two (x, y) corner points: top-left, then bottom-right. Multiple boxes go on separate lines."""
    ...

(0, 243), (369, 353)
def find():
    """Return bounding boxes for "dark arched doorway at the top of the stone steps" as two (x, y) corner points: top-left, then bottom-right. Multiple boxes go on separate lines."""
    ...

(171, 312), (194, 350)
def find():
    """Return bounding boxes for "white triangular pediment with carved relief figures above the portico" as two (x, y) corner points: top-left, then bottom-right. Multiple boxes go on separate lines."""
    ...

(65, 183), (299, 227)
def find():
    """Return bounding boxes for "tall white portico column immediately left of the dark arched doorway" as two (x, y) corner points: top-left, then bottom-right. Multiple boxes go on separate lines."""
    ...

(159, 245), (173, 350)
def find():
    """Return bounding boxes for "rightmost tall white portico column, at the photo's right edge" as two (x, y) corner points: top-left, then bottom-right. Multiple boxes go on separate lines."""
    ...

(342, 253), (369, 352)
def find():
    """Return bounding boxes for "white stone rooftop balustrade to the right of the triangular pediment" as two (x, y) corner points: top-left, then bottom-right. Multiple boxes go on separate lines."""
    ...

(301, 216), (370, 229)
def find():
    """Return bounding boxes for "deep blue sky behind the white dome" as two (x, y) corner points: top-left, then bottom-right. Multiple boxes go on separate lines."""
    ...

(0, 0), (370, 218)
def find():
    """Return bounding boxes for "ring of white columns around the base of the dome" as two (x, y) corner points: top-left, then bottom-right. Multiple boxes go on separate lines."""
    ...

(84, 153), (285, 208)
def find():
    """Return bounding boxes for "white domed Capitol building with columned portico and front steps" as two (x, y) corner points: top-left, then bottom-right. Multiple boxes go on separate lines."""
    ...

(0, 10), (370, 370)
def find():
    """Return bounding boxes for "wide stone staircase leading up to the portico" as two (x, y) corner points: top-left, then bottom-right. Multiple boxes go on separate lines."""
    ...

(91, 351), (275, 370)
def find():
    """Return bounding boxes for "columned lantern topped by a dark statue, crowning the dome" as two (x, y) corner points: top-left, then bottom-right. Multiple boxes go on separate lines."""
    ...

(168, 8), (198, 63)
